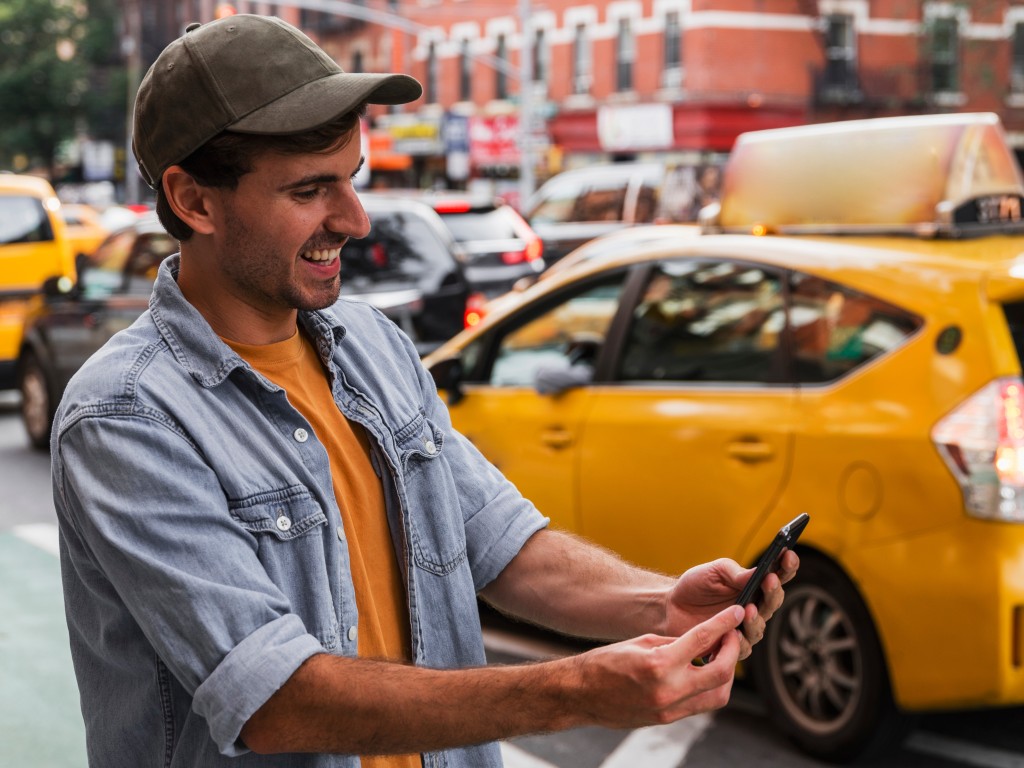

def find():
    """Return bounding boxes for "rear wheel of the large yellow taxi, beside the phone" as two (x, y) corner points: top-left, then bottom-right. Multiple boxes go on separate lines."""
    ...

(751, 552), (910, 763)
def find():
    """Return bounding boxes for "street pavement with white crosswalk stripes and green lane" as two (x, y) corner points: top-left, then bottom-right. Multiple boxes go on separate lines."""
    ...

(6, 393), (1024, 768)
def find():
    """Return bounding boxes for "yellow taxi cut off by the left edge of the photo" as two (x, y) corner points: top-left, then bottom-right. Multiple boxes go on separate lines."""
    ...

(0, 173), (75, 389)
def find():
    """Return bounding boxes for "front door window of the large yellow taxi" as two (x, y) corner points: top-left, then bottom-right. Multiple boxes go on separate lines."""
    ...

(484, 272), (626, 387)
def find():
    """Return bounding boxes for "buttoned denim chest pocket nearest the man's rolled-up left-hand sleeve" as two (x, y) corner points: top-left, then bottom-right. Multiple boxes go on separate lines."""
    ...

(230, 488), (340, 648)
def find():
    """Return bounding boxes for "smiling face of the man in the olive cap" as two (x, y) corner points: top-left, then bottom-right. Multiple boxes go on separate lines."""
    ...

(199, 129), (370, 318)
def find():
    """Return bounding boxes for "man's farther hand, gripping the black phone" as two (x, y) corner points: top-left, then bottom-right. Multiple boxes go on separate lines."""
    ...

(666, 550), (800, 658)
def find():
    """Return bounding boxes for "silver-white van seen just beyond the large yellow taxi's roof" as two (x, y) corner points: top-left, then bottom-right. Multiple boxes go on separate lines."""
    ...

(523, 163), (666, 265)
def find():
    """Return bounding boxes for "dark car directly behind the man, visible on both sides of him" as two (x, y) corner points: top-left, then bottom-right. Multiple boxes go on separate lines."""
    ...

(16, 196), (469, 449)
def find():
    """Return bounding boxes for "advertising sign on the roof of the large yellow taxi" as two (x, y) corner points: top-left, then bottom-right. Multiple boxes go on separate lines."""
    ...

(701, 113), (1024, 237)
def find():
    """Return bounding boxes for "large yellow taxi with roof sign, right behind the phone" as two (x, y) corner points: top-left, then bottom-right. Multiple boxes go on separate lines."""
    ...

(424, 115), (1024, 760)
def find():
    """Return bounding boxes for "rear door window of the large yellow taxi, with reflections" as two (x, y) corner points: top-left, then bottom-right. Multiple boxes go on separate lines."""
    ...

(617, 260), (785, 383)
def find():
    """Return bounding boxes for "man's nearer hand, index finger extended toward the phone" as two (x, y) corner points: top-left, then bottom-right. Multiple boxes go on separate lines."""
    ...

(571, 606), (743, 728)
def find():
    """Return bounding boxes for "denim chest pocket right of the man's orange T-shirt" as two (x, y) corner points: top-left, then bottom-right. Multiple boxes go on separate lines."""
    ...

(399, 415), (466, 575)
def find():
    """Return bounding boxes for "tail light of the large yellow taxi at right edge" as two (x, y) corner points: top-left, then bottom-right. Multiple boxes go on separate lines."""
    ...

(932, 378), (1024, 522)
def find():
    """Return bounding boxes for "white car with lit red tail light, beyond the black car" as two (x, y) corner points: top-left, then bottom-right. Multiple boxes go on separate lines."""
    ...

(382, 190), (545, 298)
